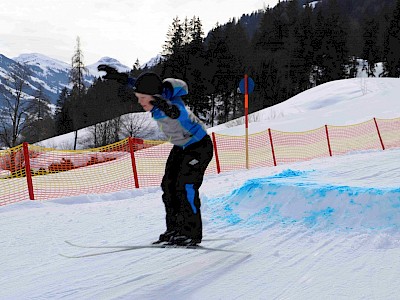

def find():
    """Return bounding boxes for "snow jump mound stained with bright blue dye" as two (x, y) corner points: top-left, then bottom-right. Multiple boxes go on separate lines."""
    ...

(207, 169), (400, 231)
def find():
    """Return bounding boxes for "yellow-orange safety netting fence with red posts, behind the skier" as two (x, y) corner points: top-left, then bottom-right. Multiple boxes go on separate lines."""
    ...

(0, 118), (400, 205)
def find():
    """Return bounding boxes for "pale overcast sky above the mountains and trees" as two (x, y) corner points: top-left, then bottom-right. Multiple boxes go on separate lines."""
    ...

(0, 0), (278, 66)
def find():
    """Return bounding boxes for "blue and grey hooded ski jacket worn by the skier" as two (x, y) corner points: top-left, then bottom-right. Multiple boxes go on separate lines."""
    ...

(151, 78), (207, 149)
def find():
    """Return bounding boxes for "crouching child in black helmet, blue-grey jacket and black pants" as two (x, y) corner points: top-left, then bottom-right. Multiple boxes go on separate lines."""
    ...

(98, 65), (213, 245)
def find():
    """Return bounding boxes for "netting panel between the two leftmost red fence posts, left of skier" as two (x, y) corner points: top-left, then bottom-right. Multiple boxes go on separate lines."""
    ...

(25, 139), (134, 200)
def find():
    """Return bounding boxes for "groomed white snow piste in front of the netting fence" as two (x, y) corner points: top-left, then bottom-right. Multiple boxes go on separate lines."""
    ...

(0, 150), (400, 299)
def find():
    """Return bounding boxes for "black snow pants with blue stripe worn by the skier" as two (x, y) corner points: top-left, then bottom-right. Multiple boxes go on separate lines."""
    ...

(161, 135), (213, 241)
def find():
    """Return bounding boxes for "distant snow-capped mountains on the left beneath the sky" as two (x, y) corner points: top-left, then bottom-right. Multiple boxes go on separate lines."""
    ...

(0, 53), (130, 104)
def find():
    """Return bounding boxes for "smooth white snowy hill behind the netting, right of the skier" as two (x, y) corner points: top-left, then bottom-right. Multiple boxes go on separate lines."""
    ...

(214, 78), (400, 135)
